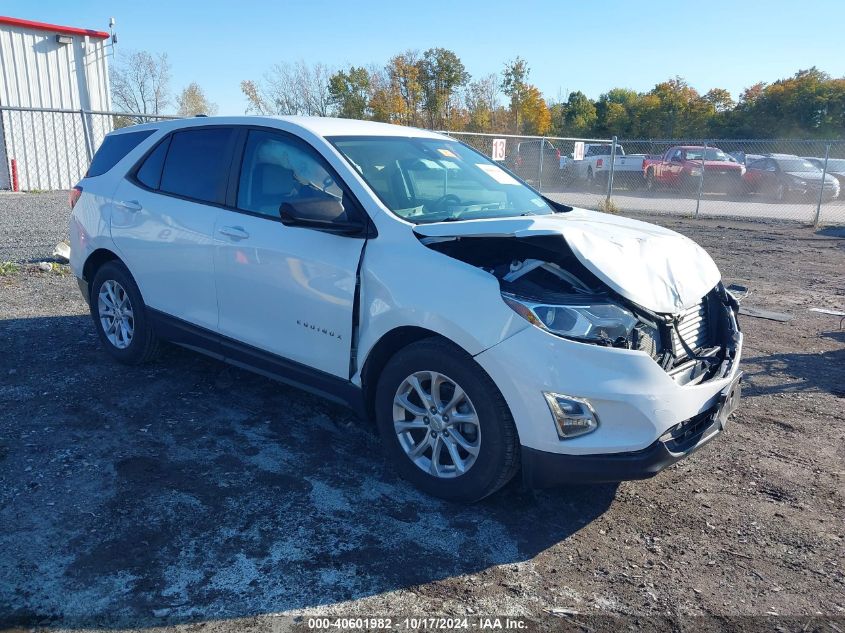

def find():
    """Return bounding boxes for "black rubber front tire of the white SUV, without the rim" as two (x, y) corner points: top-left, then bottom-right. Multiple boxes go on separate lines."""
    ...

(375, 340), (518, 502)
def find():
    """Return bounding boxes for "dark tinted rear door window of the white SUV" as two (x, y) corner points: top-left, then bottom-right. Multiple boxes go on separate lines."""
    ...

(160, 128), (233, 202)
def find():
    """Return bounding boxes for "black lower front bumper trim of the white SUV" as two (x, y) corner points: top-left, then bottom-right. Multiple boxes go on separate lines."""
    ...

(522, 374), (742, 488)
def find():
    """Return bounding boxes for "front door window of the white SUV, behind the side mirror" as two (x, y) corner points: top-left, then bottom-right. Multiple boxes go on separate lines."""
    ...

(238, 130), (348, 221)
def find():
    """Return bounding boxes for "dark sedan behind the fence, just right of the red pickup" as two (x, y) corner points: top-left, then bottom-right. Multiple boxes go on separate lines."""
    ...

(744, 154), (841, 202)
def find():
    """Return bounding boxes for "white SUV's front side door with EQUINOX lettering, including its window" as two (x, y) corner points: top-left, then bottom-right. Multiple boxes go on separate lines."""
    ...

(214, 129), (364, 379)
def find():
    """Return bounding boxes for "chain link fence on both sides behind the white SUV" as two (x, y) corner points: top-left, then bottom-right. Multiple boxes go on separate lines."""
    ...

(0, 106), (845, 225)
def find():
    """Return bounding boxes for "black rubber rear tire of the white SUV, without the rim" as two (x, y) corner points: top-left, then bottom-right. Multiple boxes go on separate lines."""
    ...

(89, 261), (152, 365)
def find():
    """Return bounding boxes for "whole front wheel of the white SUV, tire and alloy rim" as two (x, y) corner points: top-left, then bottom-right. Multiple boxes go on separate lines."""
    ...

(375, 338), (519, 503)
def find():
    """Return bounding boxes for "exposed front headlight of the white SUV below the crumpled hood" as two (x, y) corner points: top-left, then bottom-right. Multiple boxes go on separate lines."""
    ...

(502, 293), (637, 345)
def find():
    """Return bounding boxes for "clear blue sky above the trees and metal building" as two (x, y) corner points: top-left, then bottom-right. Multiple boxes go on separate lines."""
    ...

(0, 0), (845, 114)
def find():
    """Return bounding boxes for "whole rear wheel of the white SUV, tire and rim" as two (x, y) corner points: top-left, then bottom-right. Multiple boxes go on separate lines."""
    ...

(89, 260), (159, 365)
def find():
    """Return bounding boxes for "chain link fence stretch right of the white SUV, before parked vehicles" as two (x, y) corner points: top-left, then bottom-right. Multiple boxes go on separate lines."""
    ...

(444, 132), (845, 226)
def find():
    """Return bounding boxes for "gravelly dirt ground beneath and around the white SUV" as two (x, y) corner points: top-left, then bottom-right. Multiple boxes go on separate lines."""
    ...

(0, 217), (845, 631)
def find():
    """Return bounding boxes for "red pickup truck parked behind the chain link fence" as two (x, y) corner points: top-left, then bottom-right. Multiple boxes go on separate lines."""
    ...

(643, 145), (745, 194)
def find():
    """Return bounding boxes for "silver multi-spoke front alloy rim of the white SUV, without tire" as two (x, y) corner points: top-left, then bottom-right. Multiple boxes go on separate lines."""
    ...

(393, 371), (481, 479)
